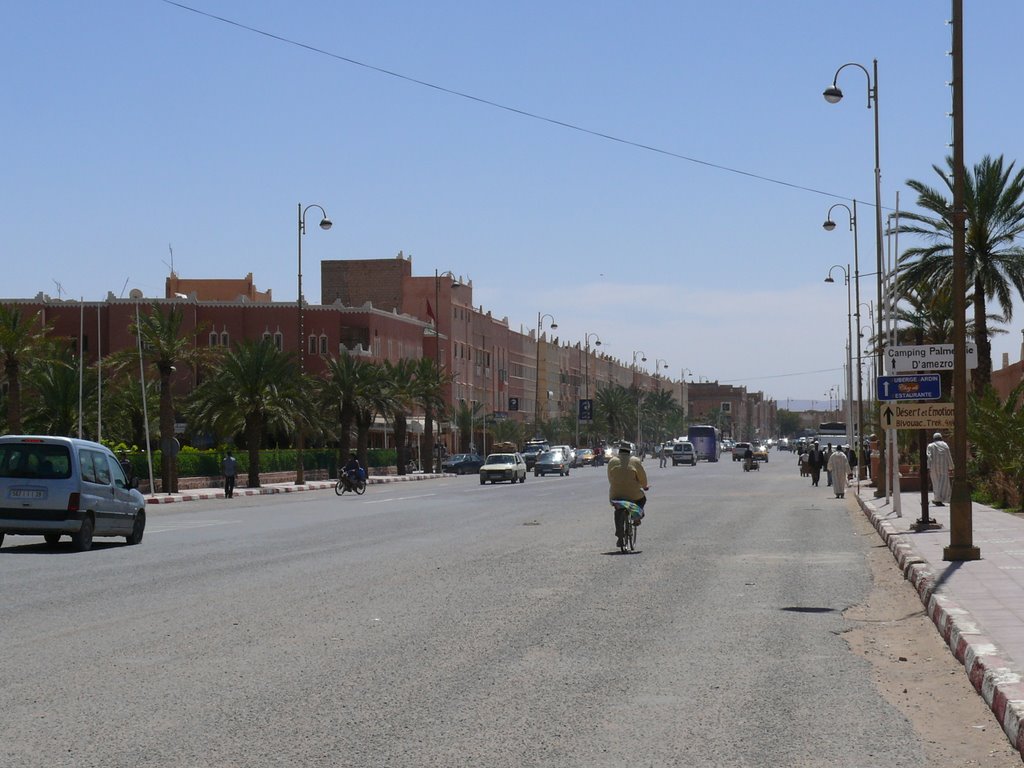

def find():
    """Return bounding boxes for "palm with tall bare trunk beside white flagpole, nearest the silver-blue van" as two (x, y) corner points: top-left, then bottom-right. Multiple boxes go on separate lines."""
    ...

(130, 303), (199, 494)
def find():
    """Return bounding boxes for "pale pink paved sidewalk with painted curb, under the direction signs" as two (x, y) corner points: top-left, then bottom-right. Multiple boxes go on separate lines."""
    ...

(851, 484), (1024, 758)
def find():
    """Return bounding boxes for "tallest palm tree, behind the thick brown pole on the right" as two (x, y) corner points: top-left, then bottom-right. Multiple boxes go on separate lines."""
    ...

(899, 155), (1024, 393)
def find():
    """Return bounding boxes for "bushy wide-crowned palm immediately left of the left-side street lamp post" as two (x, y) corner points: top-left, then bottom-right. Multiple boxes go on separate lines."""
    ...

(187, 339), (304, 487)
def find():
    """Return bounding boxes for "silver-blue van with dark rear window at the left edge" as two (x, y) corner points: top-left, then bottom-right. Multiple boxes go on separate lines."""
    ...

(0, 435), (145, 552)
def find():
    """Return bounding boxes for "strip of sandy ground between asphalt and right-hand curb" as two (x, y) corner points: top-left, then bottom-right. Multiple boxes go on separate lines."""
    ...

(845, 500), (1022, 768)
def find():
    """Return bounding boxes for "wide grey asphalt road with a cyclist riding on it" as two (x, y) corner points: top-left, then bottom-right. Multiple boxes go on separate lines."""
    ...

(0, 455), (946, 768)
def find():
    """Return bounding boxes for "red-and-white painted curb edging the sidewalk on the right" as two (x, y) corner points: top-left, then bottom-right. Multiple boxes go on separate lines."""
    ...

(857, 497), (1024, 759)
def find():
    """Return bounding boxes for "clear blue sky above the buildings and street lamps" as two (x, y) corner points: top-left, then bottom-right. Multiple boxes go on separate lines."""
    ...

(0, 0), (1024, 408)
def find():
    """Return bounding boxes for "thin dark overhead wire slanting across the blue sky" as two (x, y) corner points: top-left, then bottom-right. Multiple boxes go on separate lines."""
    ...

(161, 0), (866, 205)
